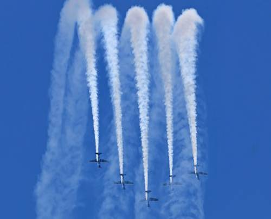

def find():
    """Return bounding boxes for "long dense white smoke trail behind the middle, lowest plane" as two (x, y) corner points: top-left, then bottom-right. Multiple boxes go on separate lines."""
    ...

(122, 7), (149, 191)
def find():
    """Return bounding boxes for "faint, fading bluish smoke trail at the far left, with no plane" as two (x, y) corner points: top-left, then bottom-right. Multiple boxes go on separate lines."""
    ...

(35, 0), (80, 218)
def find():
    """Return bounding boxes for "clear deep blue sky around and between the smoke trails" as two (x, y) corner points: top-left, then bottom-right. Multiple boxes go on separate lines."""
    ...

(0, 0), (271, 219)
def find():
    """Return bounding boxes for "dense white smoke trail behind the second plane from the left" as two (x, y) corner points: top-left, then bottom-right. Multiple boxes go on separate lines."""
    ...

(95, 5), (123, 174)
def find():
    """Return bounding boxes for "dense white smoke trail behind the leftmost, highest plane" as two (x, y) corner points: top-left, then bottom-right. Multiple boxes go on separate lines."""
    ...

(78, 0), (99, 157)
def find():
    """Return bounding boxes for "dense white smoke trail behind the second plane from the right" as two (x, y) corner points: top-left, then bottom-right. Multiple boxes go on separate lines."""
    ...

(153, 4), (174, 179)
